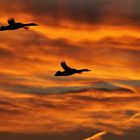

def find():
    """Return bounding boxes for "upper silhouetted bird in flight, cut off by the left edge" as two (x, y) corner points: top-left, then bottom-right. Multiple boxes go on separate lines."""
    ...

(0, 18), (38, 31)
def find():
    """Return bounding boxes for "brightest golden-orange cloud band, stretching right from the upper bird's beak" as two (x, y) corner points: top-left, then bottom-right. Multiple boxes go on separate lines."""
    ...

(34, 25), (140, 42)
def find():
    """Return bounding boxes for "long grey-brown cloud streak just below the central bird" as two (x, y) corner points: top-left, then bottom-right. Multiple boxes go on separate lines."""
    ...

(0, 82), (133, 95)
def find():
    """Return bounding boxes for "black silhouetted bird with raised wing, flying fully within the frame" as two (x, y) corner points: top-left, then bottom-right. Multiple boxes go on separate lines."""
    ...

(55, 62), (90, 76)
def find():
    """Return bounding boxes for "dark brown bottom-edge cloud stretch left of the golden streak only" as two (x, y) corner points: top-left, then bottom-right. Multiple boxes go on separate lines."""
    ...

(0, 129), (97, 140)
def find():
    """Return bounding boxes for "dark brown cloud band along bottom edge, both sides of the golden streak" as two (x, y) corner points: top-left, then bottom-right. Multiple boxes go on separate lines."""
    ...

(0, 129), (139, 140)
